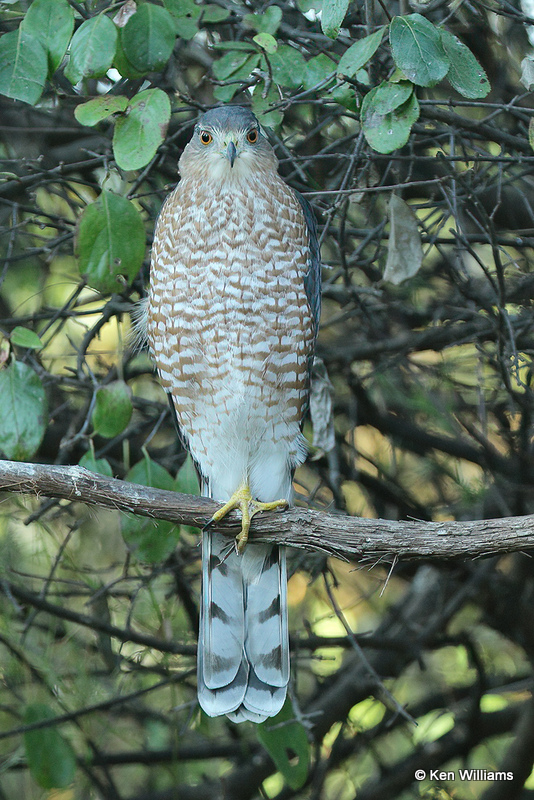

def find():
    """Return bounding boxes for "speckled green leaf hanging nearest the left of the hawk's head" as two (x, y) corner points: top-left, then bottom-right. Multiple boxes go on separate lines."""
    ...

(113, 89), (171, 169)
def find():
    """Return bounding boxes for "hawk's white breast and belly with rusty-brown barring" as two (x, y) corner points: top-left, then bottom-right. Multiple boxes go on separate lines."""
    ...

(148, 175), (313, 500)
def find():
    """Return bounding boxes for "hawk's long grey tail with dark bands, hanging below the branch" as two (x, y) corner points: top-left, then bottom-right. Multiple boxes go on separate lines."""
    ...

(198, 532), (289, 722)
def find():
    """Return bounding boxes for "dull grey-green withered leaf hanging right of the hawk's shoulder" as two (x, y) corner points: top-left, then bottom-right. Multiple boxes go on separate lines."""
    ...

(384, 194), (423, 285)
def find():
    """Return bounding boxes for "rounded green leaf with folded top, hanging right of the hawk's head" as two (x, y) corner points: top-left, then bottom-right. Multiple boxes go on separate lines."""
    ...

(360, 86), (419, 153)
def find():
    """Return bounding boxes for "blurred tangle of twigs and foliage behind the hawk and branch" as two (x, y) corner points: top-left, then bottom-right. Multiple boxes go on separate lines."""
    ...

(0, 0), (534, 800)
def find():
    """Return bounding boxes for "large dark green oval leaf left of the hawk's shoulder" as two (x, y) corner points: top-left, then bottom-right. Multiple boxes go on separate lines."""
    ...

(75, 191), (145, 292)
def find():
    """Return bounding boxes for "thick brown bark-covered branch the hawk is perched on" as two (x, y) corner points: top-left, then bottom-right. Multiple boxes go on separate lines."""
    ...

(0, 461), (534, 560)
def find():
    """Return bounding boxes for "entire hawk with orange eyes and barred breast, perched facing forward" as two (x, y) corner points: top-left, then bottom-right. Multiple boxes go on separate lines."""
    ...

(148, 106), (320, 722)
